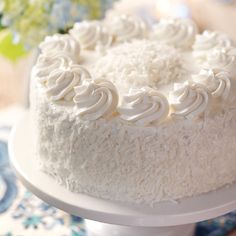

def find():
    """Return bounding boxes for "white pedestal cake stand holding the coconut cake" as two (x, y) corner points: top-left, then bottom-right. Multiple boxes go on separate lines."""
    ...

(9, 113), (236, 236)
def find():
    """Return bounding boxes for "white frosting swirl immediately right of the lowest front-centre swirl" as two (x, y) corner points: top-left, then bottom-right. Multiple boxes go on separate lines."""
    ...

(169, 82), (209, 120)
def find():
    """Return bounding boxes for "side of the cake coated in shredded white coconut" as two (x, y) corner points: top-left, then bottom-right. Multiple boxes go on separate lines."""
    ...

(32, 79), (236, 205)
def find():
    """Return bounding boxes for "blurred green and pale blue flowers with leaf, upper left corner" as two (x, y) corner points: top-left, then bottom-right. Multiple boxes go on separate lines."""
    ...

(0, 0), (115, 58)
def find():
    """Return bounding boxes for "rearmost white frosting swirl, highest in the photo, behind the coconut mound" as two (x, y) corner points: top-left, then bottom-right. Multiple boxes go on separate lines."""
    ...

(108, 15), (147, 42)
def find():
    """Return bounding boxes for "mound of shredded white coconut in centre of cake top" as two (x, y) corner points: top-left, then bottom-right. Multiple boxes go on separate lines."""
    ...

(92, 40), (185, 92)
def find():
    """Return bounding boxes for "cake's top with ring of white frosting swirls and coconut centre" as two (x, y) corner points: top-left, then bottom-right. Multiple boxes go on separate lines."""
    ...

(32, 15), (236, 126)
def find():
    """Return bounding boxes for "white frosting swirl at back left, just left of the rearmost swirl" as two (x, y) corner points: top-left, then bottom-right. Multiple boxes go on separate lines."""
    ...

(69, 21), (112, 49)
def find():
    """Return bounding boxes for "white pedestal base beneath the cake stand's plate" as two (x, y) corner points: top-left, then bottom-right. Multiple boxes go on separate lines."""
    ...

(85, 220), (195, 236)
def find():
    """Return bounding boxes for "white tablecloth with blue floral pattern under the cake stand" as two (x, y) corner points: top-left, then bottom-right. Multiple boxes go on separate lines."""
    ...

(0, 107), (236, 236)
